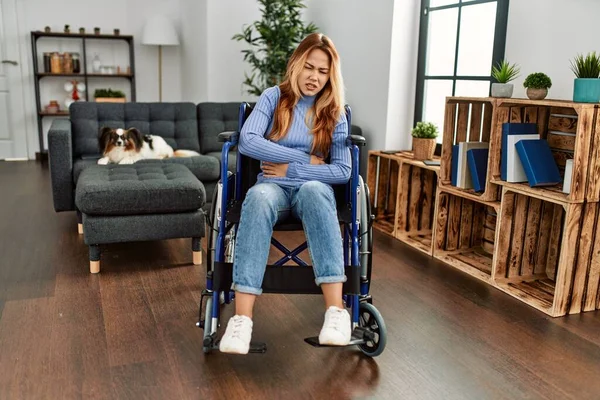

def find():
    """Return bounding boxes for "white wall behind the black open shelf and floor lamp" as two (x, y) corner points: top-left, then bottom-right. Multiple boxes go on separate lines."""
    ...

(17, 0), (182, 158)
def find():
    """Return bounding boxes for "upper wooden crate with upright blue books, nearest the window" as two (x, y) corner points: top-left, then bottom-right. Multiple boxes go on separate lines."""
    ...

(440, 97), (500, 201)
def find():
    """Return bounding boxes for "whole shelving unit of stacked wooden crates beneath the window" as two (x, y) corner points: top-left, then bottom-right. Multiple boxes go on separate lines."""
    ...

(368, 97), (600, 317)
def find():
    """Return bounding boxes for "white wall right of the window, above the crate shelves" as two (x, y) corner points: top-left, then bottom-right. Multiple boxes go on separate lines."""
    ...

(506, 0), (600, 100)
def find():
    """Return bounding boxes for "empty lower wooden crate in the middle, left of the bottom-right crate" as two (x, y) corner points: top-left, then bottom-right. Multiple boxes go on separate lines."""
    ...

(433, 187), (500, 283)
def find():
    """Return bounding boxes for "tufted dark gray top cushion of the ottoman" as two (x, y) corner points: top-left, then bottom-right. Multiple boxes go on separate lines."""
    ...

(75, 163), (206, 215)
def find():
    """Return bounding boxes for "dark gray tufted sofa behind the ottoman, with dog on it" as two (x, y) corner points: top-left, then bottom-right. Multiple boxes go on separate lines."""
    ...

(48, 102), (240, 212)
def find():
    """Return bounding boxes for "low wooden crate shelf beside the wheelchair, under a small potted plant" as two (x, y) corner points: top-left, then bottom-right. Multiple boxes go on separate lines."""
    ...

(368, 151), (439, 255)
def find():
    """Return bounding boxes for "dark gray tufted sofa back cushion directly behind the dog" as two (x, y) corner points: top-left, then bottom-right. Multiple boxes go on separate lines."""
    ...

(69, 102), (200, 158)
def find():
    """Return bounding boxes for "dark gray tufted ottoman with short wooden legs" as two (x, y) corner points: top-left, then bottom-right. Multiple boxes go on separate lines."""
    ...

(75, 163), (206, 273)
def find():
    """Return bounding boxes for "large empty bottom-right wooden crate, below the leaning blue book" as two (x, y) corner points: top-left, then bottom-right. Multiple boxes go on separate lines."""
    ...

(492, 188), (600, 317)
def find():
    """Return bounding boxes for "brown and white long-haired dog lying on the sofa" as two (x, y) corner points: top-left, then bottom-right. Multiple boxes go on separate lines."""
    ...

(98, 127), (200, 165)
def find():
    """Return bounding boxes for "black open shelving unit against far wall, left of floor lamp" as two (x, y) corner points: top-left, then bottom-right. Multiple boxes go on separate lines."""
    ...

(31, 31), (136, 159)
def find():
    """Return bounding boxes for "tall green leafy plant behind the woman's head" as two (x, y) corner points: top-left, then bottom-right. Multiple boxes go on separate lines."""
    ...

(232, 0), (318, 96)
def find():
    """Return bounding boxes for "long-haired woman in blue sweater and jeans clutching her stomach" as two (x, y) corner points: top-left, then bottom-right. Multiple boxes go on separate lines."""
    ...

(219, 33), (351, 354)
